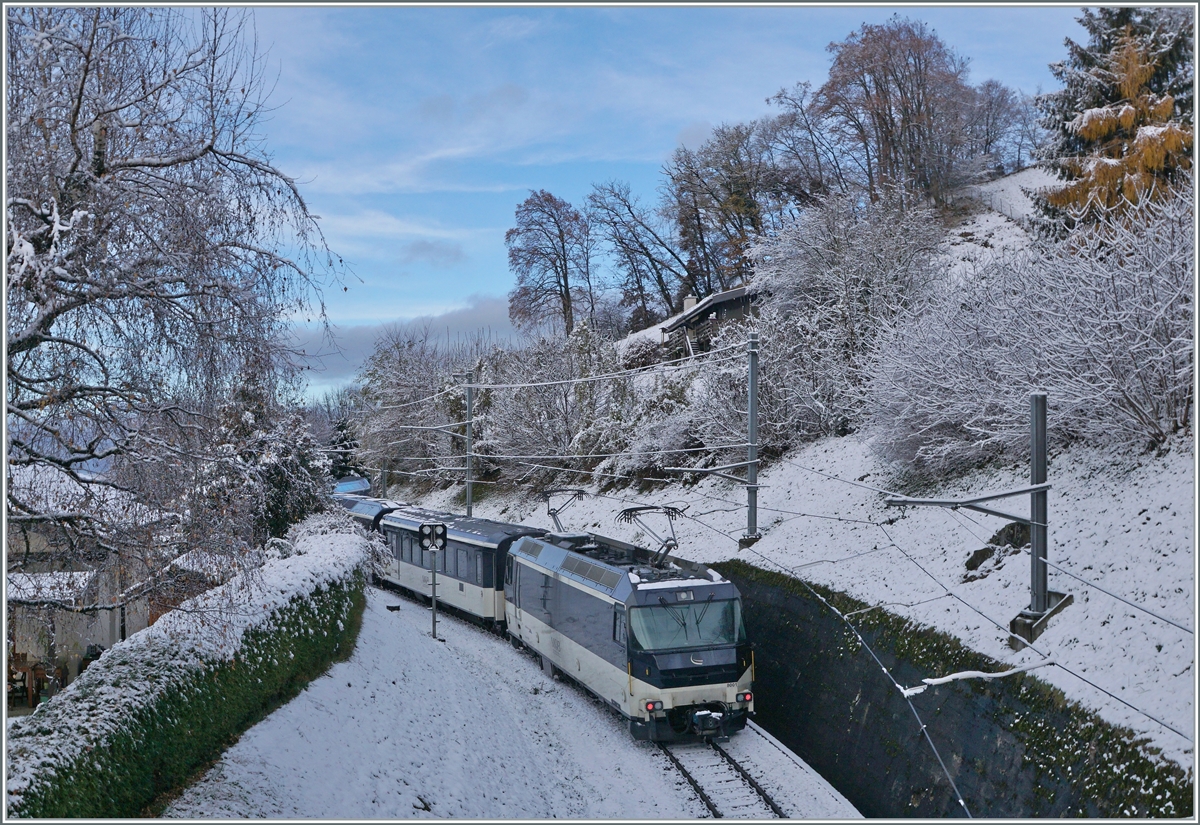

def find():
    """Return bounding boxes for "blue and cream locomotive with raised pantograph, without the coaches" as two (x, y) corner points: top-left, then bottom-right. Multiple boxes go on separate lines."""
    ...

(505, 532), (754, 741)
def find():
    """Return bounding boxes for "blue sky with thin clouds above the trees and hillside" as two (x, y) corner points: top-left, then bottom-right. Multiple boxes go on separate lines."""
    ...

(254, 5), (1085, 395)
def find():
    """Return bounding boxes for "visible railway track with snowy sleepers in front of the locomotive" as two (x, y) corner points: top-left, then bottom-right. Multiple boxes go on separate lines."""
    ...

(659, 742), (787, 819)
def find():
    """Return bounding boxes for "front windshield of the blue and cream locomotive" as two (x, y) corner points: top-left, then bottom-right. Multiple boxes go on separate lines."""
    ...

(629, 598), (746, 650)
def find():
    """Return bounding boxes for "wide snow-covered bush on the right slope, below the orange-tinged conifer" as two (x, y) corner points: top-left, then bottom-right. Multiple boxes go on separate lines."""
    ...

(871, 181), (1195, 471)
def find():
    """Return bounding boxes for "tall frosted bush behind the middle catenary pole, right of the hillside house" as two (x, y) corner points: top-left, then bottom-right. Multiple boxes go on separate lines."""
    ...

(692, 198), (941, 451)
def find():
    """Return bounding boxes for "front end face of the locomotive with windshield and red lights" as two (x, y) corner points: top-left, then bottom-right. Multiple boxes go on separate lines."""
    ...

(618, 579), (754, 741)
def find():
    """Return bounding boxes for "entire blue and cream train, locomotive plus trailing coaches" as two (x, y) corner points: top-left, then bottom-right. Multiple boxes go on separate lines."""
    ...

(334, 483), (755, 742)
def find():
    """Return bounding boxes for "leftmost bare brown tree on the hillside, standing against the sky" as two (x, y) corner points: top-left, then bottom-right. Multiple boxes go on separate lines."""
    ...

(504, 189), (596, 335)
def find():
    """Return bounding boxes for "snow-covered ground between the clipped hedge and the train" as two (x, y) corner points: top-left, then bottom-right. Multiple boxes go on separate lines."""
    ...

(164, 589), (857, 819)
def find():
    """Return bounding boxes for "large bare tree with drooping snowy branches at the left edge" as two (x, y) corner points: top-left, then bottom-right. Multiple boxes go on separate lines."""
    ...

(5, 7), (340, 606)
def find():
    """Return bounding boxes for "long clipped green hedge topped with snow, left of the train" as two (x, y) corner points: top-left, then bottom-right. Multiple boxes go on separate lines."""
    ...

(6, 513), (372, 818)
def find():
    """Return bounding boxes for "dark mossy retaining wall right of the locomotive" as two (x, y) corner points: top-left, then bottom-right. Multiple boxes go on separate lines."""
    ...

(715, 562), (1193, 818)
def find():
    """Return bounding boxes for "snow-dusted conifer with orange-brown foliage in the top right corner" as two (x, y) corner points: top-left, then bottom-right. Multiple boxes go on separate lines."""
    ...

(1037, 8), (1194, 221)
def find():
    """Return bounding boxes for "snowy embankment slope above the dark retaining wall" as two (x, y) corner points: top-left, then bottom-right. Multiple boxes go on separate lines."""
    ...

(426, 431), (1195, 769)
